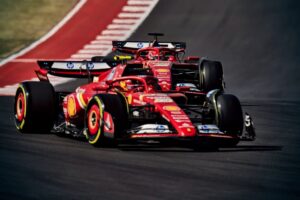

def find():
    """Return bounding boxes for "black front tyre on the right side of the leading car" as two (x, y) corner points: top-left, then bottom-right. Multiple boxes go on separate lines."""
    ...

(217, 94), (244, 146)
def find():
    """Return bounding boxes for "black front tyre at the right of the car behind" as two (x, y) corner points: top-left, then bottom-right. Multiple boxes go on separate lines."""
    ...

(200, 60), (223, 92)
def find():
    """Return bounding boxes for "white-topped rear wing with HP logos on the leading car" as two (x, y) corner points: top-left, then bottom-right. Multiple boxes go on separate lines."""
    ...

(36, 60), (111, 80)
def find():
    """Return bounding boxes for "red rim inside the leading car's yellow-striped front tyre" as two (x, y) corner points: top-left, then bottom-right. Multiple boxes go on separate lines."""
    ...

(88, 105), (100, 135)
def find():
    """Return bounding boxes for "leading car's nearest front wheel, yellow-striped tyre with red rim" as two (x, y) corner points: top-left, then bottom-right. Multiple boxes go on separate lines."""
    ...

(85, 94), (127, 147)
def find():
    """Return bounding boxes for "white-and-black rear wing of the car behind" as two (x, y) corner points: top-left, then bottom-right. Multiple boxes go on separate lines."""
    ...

(112, 41), (186, 53)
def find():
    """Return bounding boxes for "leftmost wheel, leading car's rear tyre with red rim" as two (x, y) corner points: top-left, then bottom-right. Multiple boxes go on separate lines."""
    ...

(14, 82), (56, 133)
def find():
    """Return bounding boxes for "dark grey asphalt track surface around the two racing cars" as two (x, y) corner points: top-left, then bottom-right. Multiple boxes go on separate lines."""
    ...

(0, 0), (300, 199)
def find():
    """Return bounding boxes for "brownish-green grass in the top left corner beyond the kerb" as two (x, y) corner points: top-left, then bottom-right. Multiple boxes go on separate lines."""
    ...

(0, 0), (77, 59)
